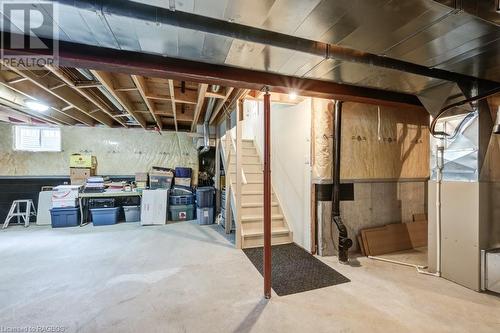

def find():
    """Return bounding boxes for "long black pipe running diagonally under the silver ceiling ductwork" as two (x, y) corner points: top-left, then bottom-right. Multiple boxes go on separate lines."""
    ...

(56, 0), (498, 87)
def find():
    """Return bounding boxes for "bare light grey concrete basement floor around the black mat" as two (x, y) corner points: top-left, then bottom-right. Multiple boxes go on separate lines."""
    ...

(0, 222), (500, 333)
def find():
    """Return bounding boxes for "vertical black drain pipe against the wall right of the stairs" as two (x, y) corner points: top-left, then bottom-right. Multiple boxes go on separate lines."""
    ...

(332, 101), (352, 263)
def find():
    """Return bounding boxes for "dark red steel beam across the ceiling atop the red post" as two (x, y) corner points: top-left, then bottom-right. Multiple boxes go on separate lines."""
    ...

(4, 38), (422, 108)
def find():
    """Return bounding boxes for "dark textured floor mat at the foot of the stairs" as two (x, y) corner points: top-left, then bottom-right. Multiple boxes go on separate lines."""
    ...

(243, 244), (351, 296)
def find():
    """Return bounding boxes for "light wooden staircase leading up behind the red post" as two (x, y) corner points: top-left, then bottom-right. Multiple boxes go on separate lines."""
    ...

(224, 136), (293, 248)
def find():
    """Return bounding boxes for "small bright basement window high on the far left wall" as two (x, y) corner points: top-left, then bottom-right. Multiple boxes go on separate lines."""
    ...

(14, 126), (61, 152)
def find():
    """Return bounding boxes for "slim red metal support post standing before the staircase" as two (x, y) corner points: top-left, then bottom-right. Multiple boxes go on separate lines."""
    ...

(264, 89), (272, 299)
